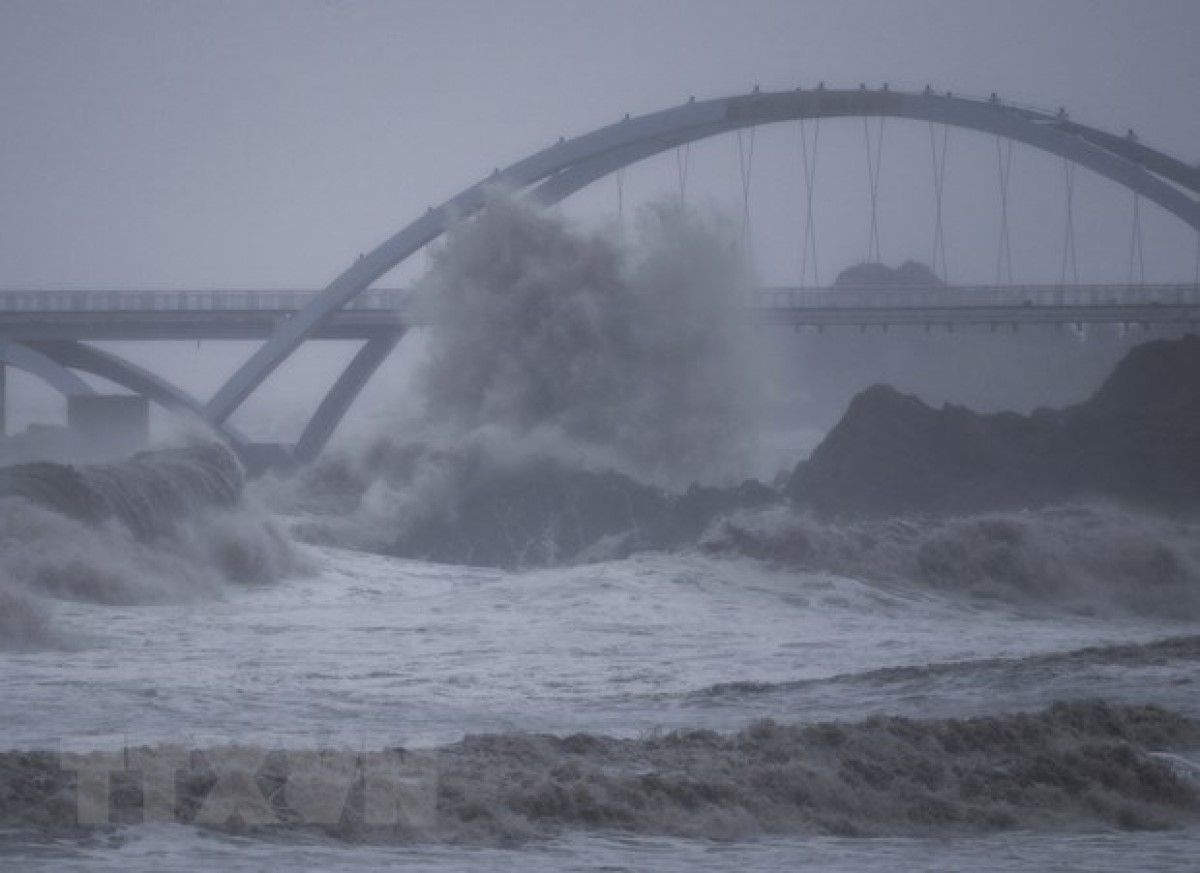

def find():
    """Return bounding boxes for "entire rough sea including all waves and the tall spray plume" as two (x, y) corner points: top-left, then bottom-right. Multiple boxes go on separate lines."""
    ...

(0, 204), (1200, 871)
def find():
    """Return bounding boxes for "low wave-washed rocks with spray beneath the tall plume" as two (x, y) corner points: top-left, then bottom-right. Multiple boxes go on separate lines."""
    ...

(275, 439), (782, 570)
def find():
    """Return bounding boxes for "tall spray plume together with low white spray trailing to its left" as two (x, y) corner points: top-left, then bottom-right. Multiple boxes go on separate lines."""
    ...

(273, 191), (762, 552)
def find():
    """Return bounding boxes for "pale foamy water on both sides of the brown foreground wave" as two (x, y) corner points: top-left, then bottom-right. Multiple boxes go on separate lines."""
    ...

(0, 548), (1200, 871)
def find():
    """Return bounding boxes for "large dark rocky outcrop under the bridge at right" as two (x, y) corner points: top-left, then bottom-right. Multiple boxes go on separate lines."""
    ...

(786, 336), (1200, 517)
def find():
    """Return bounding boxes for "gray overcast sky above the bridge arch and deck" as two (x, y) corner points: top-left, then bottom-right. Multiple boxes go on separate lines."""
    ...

(0, 0), (1200, 288)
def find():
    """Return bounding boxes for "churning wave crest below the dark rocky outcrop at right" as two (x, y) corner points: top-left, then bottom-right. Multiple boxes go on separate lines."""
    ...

(701, 505), (1200, 620)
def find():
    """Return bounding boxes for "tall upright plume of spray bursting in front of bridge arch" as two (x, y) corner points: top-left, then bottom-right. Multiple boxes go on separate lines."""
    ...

(419, 192), (760, 487)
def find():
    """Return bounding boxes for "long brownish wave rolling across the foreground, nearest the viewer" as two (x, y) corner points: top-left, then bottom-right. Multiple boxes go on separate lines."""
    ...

(0, 703), (1200, 844)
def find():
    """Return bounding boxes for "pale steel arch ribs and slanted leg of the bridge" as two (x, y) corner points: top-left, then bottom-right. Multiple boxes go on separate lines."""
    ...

(10, 86), (1200, 463)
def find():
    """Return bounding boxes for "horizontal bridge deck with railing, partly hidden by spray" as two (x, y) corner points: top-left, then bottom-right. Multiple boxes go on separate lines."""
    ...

(0, 284), (1200, 342)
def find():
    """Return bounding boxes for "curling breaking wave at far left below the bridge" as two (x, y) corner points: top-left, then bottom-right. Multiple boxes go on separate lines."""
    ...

(0, 444), (298, 649)
